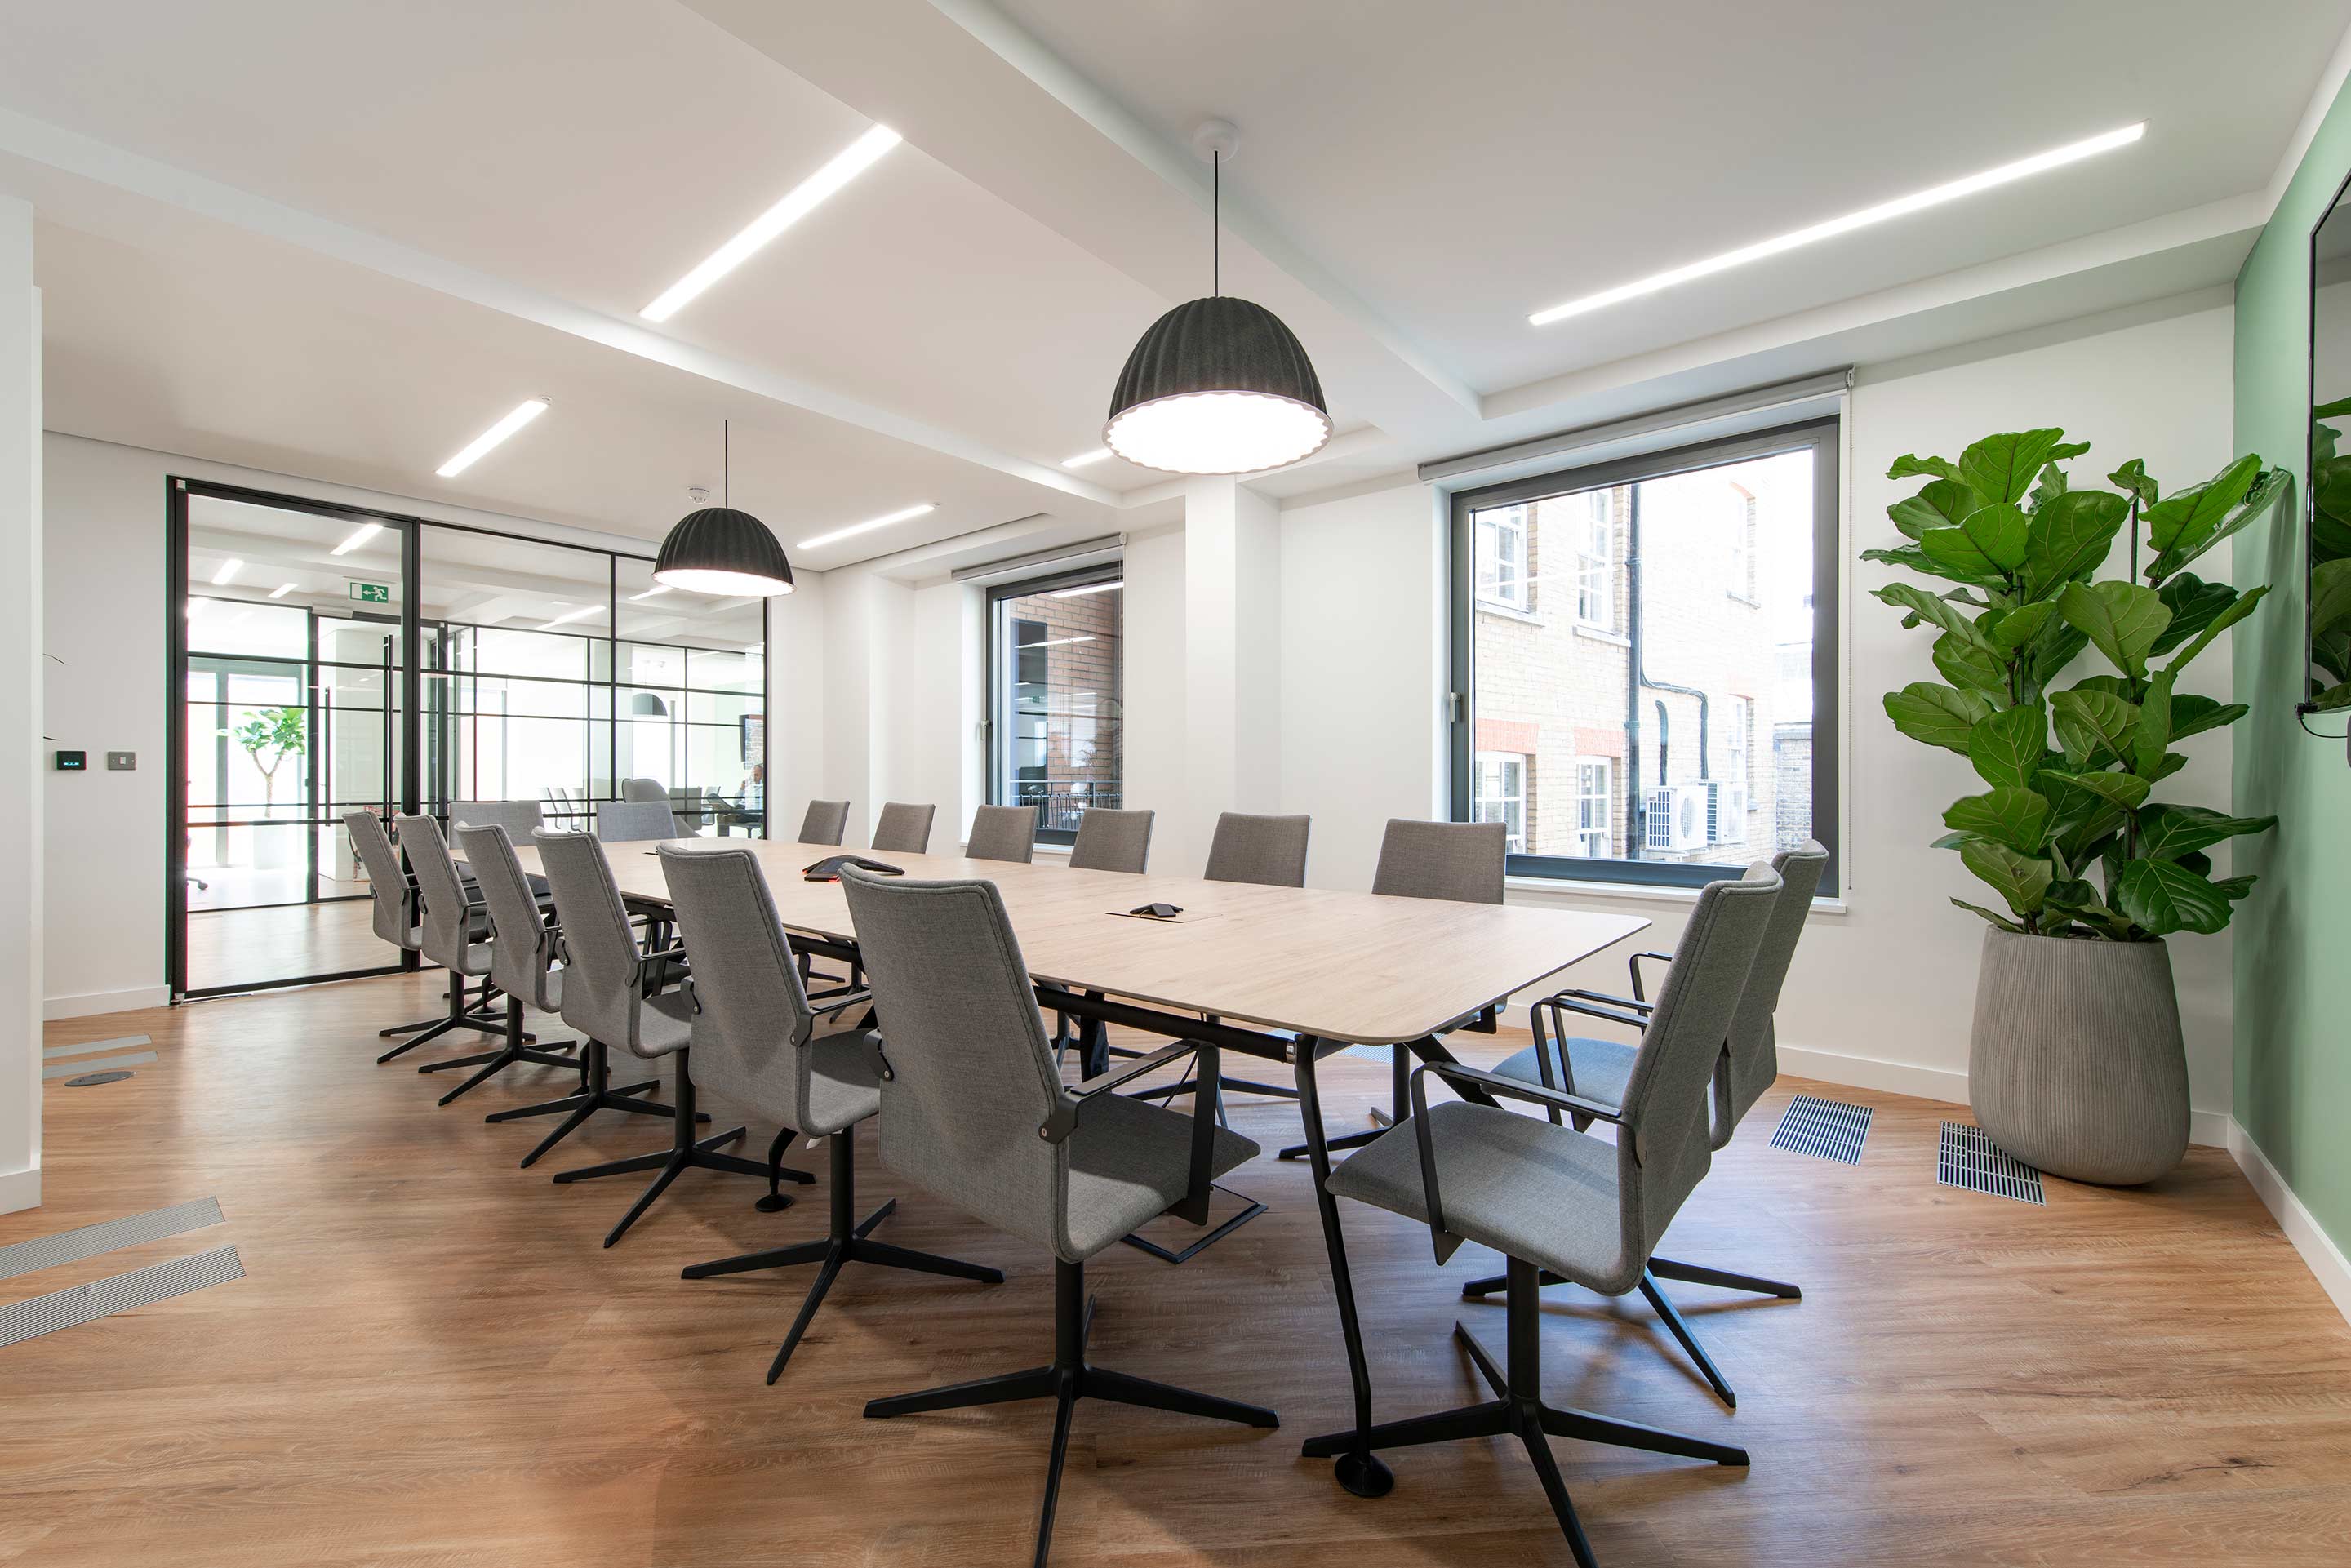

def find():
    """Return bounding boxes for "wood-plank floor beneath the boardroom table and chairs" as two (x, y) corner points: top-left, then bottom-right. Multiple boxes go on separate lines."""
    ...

(0, 978), (2351, 1568)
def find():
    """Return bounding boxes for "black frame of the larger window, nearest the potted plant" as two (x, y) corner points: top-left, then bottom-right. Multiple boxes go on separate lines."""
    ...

(1446, 414), (1843, 898)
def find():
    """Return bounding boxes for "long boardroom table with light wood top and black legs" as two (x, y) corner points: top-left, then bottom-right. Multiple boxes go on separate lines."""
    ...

(500, 839), (1648, 1498)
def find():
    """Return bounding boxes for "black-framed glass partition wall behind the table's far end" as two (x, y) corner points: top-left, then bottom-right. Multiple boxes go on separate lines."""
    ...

(167, 480), (767, 997)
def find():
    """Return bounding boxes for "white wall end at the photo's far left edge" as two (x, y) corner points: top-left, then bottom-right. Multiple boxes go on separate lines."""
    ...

(0, 198), (47, 1213)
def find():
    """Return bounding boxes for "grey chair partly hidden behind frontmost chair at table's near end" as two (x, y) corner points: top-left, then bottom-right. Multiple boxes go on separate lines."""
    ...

(1462, 839), (1829, 1408)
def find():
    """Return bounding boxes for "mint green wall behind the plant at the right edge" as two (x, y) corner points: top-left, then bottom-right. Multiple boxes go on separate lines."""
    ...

(2233, 76), (2351, 1250)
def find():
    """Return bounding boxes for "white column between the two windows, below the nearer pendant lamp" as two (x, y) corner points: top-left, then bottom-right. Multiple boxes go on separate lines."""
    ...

(1176, 480), (1282, 874)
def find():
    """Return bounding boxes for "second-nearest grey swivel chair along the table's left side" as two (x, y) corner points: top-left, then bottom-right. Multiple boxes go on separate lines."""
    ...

(660, 849), (1004, 1382)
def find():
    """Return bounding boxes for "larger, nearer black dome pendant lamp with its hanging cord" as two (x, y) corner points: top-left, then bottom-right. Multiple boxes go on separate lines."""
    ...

(1103, 120), (1331, 475)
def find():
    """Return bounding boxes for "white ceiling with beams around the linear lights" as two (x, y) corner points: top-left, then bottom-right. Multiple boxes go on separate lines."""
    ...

(0, 0), (2344, 569)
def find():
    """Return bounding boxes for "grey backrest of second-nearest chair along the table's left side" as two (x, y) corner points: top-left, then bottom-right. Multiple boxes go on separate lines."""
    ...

(660, 849), (837, 1135)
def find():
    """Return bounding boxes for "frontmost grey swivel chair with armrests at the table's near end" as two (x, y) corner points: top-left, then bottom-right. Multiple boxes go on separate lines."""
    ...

(1303, 863), (1780, 1568)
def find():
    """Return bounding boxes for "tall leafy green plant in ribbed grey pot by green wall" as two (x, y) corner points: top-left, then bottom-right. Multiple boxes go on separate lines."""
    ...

(1862, 430), (2287, 1185)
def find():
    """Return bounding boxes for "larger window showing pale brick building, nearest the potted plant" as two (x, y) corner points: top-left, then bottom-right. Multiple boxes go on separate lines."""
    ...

(1453, 419), (1838, 891)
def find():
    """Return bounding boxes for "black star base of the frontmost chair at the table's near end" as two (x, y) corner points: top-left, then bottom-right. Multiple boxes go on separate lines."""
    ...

(1300, 1258), (1747, 1568)
